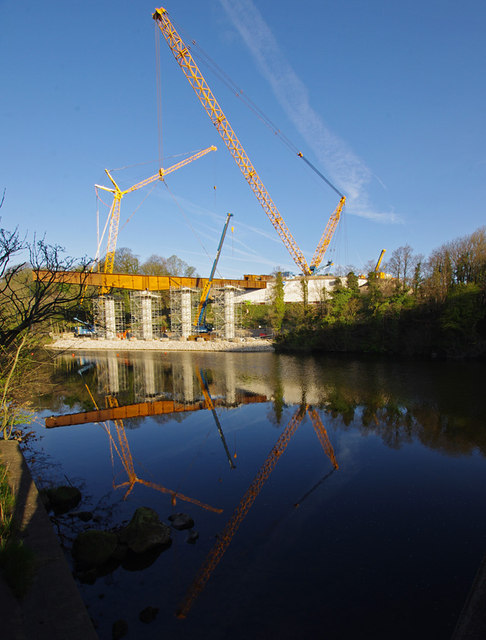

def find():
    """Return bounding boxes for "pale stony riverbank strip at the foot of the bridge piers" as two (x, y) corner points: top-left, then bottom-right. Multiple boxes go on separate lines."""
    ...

(46, 335), (274, 352)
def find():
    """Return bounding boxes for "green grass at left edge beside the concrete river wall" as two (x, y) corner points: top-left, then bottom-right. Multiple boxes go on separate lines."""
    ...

(0, 464), (35, 598)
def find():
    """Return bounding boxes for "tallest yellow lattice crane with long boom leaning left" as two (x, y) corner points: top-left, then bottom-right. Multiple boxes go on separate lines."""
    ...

(153, 7), (346, 275)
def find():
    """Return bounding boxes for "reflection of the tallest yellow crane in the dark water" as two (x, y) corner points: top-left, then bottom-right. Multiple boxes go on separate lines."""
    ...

(177, 404), (339, 618)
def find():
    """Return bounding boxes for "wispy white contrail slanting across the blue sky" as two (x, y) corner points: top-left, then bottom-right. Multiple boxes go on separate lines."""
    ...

(219, 0), (400, 222)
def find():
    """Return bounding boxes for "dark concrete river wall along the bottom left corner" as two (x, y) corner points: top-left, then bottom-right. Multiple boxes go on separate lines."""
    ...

(0, 440), (98, 640)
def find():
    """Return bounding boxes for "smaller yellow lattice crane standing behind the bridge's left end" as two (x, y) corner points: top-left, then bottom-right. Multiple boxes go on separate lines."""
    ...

(95, 146), (216, 282)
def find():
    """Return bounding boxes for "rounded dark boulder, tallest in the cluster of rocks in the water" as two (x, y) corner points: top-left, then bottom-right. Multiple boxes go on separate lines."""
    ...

(118, 507), (171, 553)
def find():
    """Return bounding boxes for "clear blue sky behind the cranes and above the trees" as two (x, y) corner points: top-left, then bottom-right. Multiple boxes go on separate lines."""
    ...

(0, 0), (486, 278)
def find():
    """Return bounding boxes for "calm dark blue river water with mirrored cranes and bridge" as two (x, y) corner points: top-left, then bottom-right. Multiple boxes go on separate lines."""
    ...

(31, 352), (486, 640)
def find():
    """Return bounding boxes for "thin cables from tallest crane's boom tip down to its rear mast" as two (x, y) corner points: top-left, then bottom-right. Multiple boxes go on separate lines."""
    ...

(171, 20), (344, 198)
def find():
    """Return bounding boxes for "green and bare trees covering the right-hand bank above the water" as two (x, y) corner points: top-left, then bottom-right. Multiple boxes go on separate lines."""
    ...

(260, 227), (486, 357)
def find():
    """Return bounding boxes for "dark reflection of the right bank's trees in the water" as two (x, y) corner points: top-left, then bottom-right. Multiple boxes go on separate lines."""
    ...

(304, 356), (486, 455)
